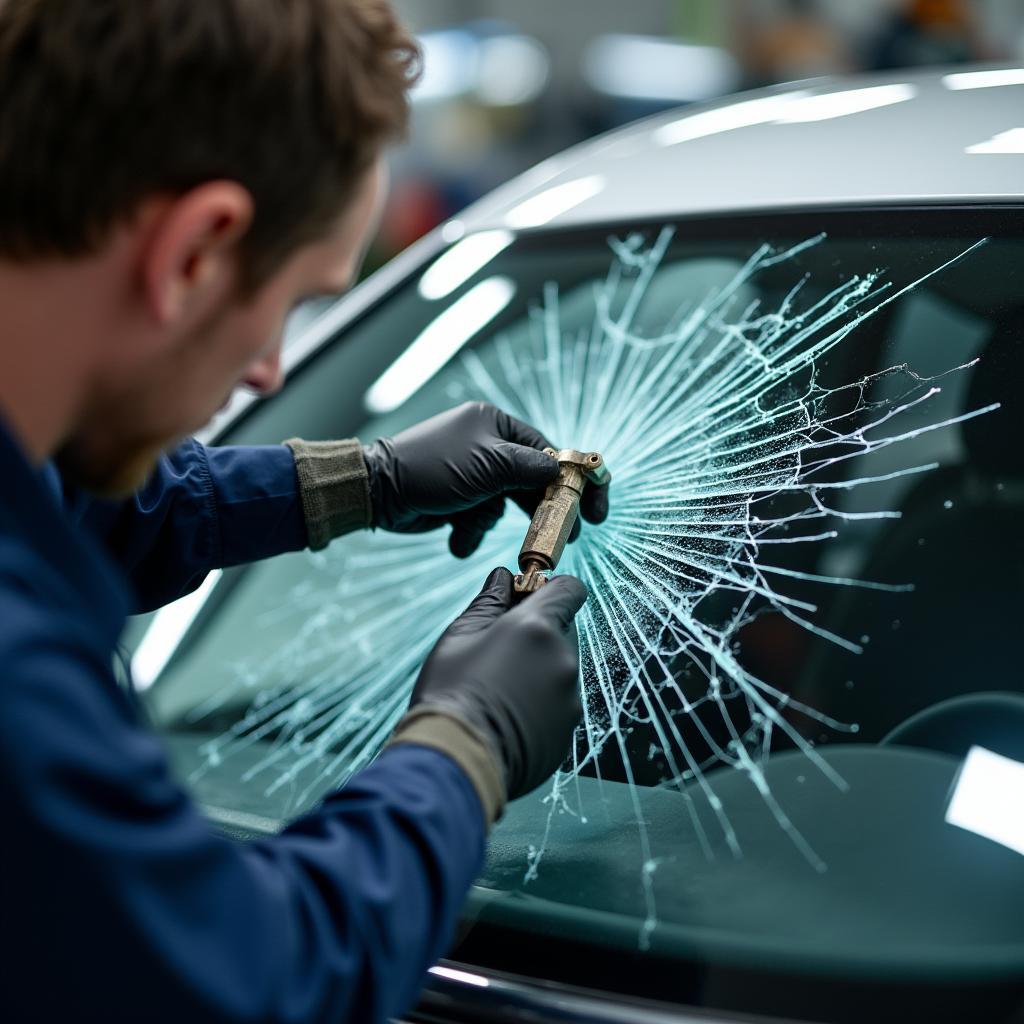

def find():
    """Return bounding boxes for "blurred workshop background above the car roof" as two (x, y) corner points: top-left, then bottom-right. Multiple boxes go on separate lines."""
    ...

(366, 0), (1024, 271)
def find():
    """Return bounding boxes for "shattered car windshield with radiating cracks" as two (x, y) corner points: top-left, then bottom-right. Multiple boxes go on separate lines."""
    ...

(146, 210), (1024, 1013)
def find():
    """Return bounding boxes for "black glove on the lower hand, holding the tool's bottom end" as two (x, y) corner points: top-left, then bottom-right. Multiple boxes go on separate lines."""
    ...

(410, 568), (587, 800)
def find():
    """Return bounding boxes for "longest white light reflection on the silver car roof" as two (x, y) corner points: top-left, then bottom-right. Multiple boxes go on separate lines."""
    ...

(651, 85), (918, 145)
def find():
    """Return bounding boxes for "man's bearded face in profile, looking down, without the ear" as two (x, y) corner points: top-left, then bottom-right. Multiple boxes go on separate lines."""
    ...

(56, 163), (386, 497)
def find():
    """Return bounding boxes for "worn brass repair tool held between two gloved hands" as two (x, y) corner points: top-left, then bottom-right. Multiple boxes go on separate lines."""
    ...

(513, 449), (611, 597)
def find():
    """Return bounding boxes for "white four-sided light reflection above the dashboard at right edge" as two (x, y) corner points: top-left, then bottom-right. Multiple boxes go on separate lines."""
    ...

(946, 746), (1024, 853)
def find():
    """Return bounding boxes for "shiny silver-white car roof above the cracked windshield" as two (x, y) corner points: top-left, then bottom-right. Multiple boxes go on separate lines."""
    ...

(460, 65), (1024, 237)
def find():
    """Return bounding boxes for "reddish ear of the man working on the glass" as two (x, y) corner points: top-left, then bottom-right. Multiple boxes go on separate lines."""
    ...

(142, 181), (254, 325)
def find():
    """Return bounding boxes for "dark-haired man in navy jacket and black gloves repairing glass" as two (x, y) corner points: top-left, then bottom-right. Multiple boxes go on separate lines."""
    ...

(0, 0), (607, 1024)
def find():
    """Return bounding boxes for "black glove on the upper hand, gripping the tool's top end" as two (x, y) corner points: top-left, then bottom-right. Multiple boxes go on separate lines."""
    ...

(362, 401), (608, 558)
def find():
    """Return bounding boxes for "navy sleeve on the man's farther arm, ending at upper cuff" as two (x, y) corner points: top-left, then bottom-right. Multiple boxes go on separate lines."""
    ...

(65, 440), (307, 612)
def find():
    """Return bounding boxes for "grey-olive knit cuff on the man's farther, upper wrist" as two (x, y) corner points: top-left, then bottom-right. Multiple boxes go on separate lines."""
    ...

(285, 437), (371, 551)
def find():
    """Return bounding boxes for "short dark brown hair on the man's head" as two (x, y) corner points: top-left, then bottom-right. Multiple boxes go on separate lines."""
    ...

(0, 0), (419, 288)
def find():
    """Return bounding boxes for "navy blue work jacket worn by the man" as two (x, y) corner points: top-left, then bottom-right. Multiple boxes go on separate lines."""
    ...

(0, 424), (483, 1024)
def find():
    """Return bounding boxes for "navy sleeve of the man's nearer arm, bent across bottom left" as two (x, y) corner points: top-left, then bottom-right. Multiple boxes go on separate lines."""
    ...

(0, 589), (484, 1024)
